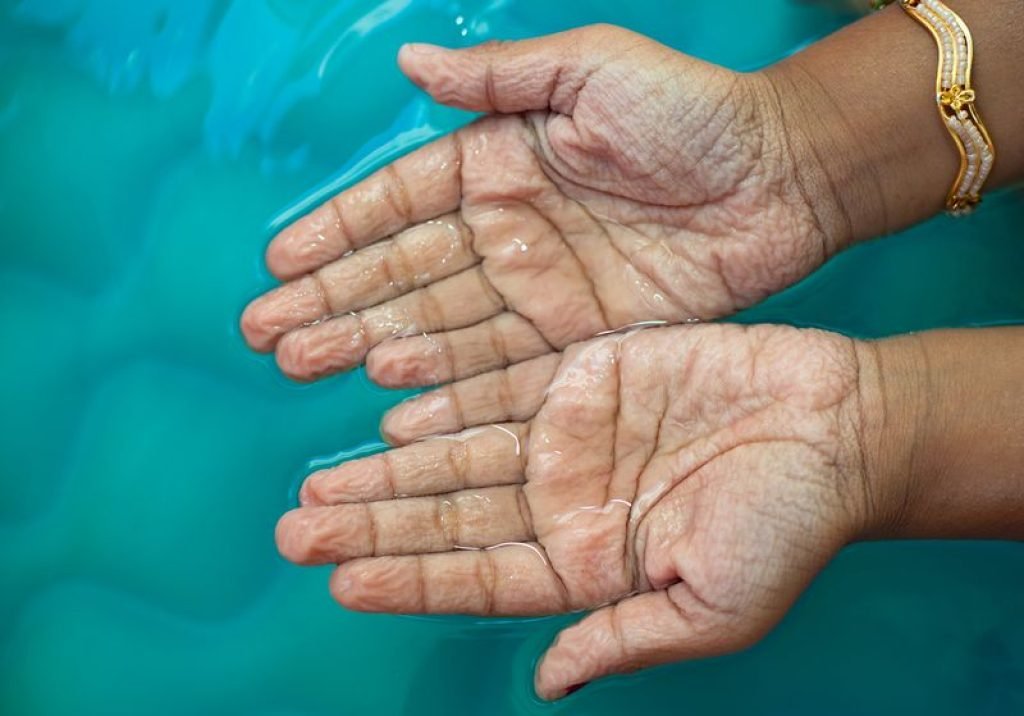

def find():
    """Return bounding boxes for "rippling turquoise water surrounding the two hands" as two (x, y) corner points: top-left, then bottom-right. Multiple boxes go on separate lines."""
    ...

(0, 0), (1024, 716)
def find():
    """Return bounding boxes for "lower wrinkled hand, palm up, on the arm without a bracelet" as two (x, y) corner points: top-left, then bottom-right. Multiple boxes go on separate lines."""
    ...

(278, 325), (869, 699)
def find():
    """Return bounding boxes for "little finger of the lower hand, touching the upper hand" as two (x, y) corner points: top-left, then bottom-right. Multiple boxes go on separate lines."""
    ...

(381, 353), (560, 445)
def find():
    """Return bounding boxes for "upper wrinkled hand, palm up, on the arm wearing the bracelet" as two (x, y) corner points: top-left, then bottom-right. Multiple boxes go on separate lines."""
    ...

(242, 27), (844, 387)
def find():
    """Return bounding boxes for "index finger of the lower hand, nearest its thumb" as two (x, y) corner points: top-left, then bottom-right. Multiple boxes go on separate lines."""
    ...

(331, 542), (569, 616)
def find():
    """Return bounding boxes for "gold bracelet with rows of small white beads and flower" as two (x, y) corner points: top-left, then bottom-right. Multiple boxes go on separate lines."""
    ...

(872, 0), (995, 216)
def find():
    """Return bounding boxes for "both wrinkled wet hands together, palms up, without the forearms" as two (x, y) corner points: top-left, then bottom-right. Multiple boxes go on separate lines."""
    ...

(242, 27), (888, 699)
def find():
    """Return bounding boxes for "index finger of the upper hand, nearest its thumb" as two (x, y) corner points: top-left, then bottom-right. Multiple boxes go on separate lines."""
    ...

(266, 135), (461, 281)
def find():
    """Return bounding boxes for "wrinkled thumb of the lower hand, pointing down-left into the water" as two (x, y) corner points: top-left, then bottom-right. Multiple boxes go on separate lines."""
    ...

(534, 583), (750, 700)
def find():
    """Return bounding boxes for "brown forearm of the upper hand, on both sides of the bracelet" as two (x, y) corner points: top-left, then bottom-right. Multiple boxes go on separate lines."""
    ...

(765, 0), (1024, 241)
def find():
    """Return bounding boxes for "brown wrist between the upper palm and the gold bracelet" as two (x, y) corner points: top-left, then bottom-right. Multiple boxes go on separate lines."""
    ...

(765, 7), (958, 244)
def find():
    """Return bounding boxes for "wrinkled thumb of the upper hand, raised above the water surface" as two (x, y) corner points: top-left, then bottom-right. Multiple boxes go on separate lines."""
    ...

(398, 26), (631, 115)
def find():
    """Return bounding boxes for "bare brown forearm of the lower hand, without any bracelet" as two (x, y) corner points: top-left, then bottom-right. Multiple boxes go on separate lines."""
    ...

(858, 327), (1024, 540)
